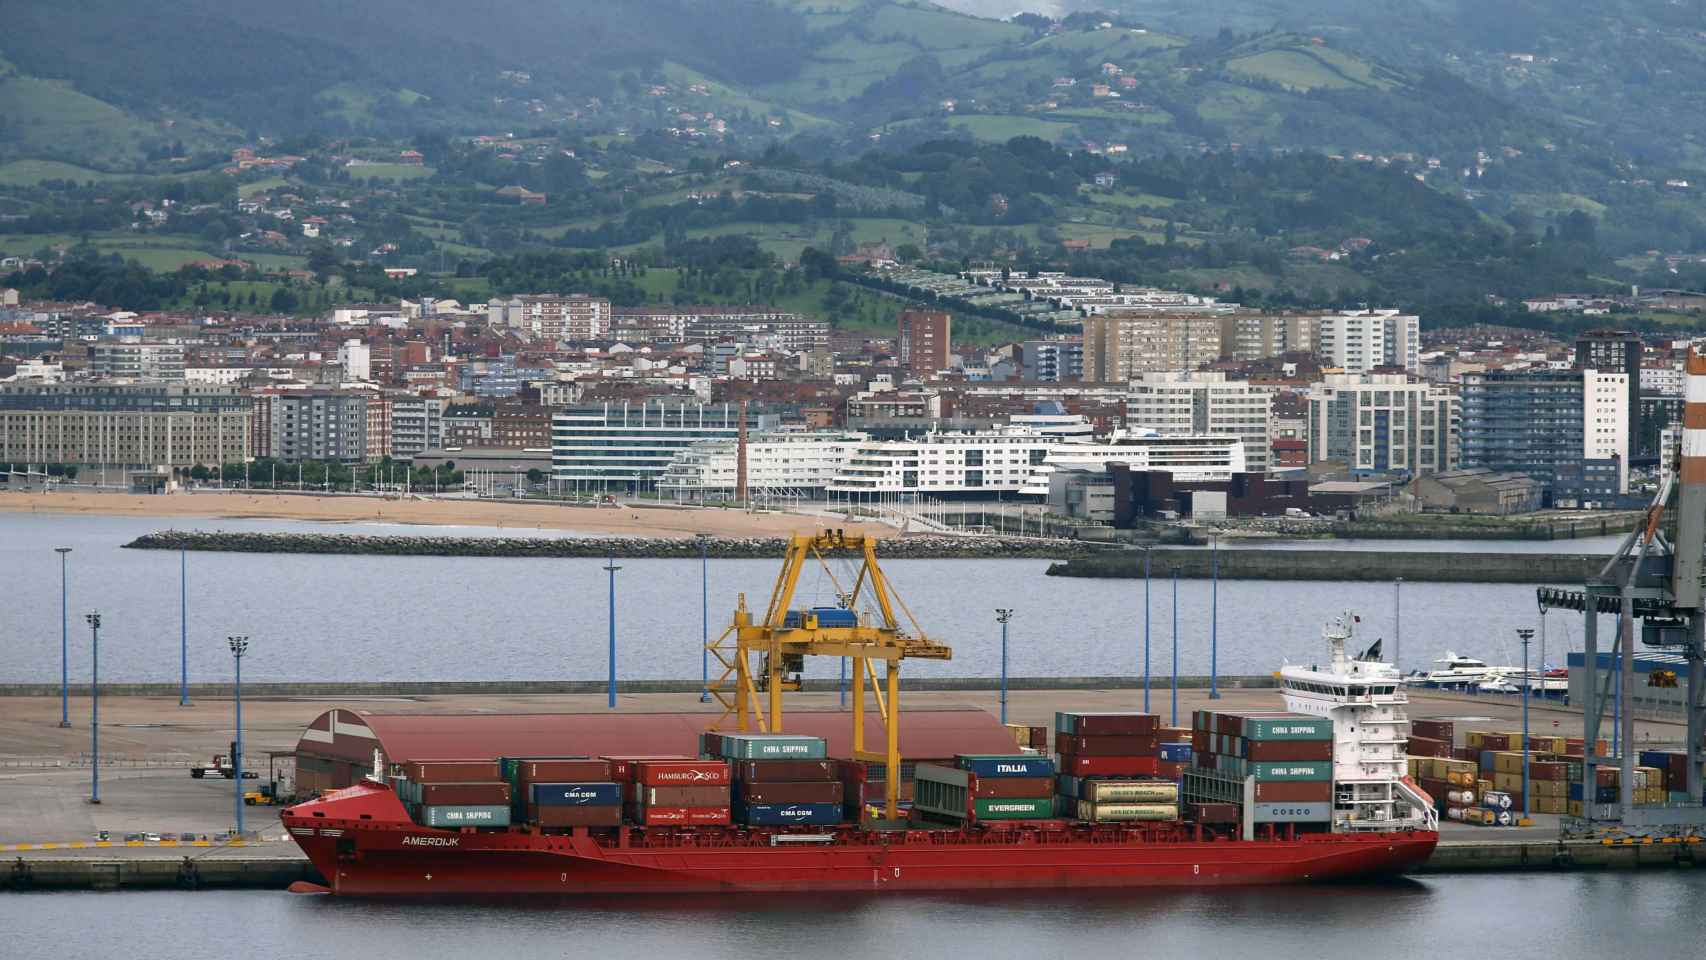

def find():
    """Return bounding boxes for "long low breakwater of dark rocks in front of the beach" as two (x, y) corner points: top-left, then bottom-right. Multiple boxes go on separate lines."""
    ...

(125, 530), (1104, 559)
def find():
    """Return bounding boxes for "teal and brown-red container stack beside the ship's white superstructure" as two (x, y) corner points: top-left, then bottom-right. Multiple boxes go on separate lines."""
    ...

(1189, 709), (1332, 825)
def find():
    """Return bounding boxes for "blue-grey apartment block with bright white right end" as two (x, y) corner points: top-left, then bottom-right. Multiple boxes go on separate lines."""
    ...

(1459, 370), (1629, 503)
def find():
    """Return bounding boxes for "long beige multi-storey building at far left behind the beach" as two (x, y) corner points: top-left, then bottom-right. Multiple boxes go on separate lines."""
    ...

(0, 382), (251, 467)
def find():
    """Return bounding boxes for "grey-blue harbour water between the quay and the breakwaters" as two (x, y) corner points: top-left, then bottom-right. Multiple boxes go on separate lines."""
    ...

(0, 513), (1616, 682)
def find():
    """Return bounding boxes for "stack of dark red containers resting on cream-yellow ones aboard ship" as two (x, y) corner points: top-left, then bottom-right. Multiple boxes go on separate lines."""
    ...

(1054, 711), (1191, 824)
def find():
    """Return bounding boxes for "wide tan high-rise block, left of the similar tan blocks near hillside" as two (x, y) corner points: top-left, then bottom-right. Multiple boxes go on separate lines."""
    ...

(1083, 309), (1220, 384)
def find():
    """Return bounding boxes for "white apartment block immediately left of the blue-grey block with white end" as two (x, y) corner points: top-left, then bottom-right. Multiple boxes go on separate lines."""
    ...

(1307, 373), (1457, 474)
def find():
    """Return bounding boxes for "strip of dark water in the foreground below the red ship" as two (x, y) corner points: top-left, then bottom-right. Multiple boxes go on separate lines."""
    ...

(0, 871), (1706, 960)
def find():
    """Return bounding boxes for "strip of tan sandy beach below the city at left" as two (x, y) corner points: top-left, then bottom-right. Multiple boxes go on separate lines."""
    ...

(0, 489), (896, 537)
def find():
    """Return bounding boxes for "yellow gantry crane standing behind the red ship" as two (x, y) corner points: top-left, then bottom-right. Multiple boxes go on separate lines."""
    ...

(708, 530), (954, 820)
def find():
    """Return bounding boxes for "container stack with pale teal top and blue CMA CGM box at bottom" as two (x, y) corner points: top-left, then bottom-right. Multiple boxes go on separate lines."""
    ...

(703, 733), (843, 827)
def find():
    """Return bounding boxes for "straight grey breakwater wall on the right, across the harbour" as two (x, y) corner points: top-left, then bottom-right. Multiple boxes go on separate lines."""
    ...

(1047, 547), (1605, 583)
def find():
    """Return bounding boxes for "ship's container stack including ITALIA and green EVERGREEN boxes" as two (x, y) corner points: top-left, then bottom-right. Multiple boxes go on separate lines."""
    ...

(913, 754), (1054, 825)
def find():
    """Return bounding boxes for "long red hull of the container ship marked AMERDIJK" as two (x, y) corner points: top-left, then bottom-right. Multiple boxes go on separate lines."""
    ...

(283, 781), (1438, 895)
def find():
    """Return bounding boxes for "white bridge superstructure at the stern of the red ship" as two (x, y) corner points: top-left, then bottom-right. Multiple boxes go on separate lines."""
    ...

(1280, 614), (1440, 830)
